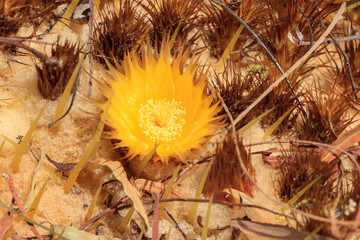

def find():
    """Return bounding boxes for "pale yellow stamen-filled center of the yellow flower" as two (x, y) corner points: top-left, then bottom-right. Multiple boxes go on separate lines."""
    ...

(139, 99), (186, 142)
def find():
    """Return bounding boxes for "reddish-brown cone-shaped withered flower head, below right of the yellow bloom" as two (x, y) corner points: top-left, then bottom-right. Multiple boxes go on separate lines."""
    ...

(203, 133), (255, 201)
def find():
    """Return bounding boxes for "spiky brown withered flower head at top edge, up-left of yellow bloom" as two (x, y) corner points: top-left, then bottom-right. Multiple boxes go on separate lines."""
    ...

(94, 0), (148, 65)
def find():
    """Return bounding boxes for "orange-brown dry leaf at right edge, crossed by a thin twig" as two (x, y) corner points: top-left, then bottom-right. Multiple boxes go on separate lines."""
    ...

(321, 124), (360, 162)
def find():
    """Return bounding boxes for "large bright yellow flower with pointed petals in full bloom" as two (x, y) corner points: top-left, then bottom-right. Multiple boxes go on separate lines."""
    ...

(103, 40), (221, 163)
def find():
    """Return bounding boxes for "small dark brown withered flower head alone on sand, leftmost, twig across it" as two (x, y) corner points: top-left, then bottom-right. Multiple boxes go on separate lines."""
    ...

(35, 40), (80, 100)
